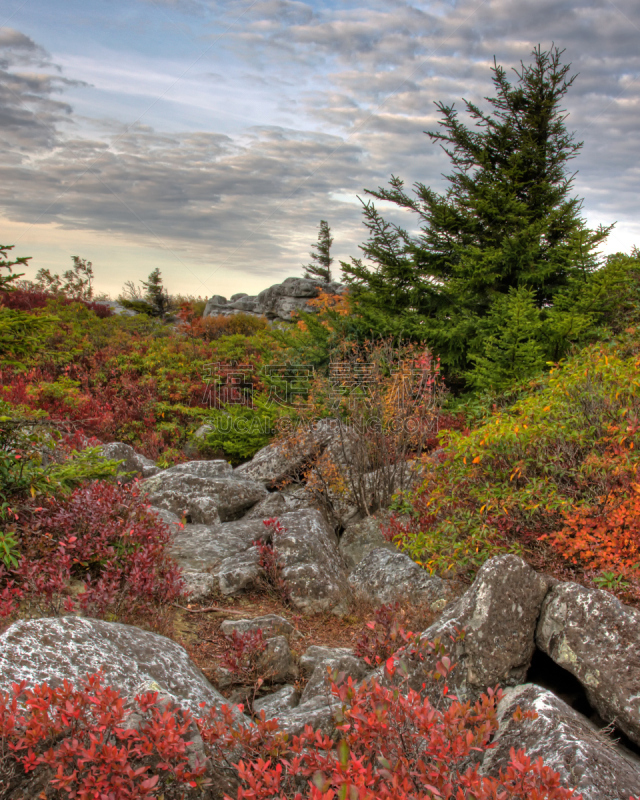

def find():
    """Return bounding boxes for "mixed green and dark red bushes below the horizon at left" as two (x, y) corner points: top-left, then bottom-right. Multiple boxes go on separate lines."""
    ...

(0, 292), (278, 461)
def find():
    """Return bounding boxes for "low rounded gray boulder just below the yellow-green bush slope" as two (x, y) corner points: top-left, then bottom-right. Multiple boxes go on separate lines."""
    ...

(349, 547), (453, 610)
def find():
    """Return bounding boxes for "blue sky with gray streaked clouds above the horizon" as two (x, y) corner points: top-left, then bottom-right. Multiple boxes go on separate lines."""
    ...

(0, 0), (640, 298)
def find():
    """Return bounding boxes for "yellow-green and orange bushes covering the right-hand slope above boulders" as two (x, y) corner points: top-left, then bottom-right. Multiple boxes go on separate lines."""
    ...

(387, 335), (640, 592)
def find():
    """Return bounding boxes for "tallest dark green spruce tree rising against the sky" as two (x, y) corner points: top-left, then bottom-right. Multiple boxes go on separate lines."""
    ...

(342, 46), (613, 388)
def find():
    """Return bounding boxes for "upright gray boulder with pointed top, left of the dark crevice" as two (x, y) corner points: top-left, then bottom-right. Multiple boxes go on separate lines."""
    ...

(396, 555), (550, 700)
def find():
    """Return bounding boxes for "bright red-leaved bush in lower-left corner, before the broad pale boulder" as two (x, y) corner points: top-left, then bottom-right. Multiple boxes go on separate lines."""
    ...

(0, 673), (206, 800)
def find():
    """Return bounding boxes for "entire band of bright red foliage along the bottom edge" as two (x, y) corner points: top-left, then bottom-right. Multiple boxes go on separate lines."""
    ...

(0, 658), (638, 800)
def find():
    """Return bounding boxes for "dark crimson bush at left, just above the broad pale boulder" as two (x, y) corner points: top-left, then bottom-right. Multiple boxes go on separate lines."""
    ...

(0, 481), (183, 618)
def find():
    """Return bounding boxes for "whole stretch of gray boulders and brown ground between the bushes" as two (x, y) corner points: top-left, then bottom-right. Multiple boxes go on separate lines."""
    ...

(0, 428), (640, 800)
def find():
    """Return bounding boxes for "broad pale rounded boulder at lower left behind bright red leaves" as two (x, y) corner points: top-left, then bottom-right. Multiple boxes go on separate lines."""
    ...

(0, 616), (232, 716)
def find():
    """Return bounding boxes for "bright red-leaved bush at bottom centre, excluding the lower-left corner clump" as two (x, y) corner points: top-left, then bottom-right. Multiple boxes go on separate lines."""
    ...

(198, 643), (608, 800)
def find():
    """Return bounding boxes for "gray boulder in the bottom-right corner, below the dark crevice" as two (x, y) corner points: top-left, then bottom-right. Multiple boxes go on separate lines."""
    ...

(481, 684), (640, 800)
